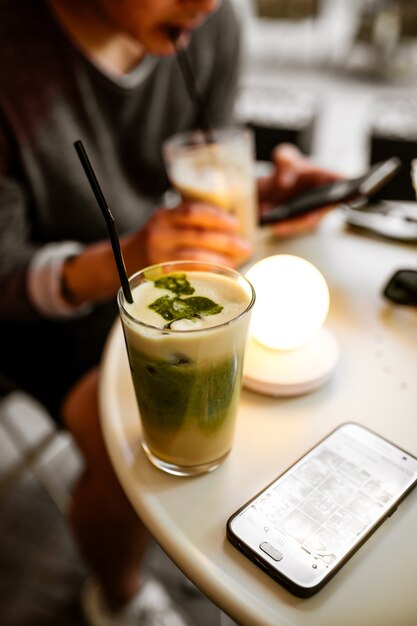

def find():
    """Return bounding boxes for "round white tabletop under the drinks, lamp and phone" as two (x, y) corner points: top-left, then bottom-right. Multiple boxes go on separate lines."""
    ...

(100, 212), (417, 626)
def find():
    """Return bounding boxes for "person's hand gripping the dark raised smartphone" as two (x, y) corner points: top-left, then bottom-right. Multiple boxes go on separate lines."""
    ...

(258, 143), (341, 237)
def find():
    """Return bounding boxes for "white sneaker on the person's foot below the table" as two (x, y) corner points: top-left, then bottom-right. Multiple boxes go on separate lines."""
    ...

(81, 578), (187, 626)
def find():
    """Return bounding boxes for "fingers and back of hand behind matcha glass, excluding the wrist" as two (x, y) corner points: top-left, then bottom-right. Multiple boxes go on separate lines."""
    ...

(135, 202), (252, 267)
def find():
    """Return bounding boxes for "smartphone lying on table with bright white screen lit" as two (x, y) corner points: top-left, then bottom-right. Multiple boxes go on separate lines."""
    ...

(227, 423), (417, 597)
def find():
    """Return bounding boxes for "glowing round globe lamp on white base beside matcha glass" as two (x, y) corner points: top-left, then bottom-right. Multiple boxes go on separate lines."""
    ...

(244, 254), (339, 396)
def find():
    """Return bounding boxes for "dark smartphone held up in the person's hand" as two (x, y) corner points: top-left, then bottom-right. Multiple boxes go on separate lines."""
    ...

(259, 157), (401, 226)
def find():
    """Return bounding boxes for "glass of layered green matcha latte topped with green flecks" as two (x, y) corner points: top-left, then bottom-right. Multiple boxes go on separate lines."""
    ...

(118, 261), (255, 476)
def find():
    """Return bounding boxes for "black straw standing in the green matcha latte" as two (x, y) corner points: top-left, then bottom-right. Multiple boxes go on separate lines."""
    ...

(74, 140), (133, 304)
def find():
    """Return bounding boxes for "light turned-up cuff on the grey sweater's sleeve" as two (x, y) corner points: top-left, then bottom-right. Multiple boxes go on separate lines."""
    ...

(27, 241), (92, 318)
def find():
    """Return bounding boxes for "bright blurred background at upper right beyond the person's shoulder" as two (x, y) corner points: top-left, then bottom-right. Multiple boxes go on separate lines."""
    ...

(235, 0), (417, 200)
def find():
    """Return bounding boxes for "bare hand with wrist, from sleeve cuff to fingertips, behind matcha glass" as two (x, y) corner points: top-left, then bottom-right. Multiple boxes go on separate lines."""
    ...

(63, 203), (252, 305)
